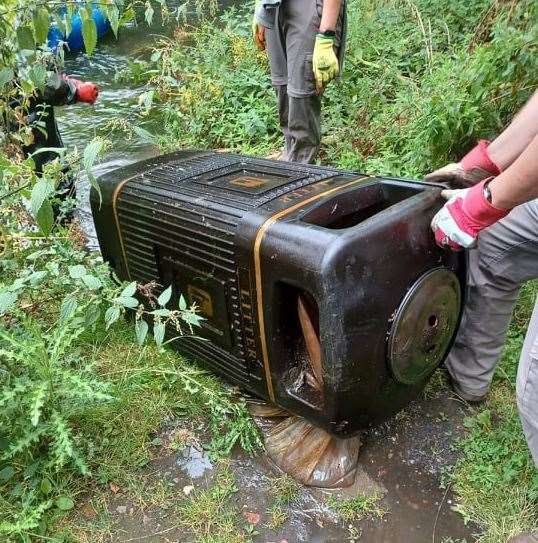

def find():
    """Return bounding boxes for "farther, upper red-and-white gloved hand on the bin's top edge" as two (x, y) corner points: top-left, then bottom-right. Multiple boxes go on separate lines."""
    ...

(424, 140), (501, 187)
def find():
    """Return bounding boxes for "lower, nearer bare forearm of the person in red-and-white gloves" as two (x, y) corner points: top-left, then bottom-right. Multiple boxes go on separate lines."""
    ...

(489, 136), (538, 209)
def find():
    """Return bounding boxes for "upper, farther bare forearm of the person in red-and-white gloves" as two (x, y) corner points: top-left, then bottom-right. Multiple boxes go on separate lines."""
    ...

(488, 92), (538, 170)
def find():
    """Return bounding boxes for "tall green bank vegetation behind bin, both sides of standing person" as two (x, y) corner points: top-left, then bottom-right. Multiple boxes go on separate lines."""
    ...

(155, 0), (538, 177)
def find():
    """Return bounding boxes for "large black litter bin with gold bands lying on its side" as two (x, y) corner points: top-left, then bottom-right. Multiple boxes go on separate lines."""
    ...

(92, 151), (466, 437)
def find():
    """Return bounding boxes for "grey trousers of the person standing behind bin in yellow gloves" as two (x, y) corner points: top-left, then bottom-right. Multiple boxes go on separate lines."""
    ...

(265, 0), (345, 163)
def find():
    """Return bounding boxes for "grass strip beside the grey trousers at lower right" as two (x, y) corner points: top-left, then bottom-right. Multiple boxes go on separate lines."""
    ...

(452, 282), (538, 543)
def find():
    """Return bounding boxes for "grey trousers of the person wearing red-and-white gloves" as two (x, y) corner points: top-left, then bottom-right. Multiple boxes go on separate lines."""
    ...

(446, 200), (538, 466)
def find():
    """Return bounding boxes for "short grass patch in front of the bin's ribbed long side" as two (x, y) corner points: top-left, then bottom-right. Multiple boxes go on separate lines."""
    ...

(19, 323), (257, 543)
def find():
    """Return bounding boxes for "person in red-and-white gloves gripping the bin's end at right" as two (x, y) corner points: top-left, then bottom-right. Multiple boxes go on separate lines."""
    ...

(426, 92), (538, 543)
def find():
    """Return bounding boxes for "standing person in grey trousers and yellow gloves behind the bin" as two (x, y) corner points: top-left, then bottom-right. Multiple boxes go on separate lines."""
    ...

(252, 0), (346, 163)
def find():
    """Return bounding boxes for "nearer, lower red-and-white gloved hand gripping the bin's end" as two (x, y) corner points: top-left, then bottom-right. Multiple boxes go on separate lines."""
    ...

(431, 178), (510, 251)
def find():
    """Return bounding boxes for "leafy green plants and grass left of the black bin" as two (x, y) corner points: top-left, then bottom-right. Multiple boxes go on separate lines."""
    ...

(0, 0), (260, 542)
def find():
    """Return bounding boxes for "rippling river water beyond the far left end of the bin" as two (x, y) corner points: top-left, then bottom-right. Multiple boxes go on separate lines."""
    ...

(56, 2), (199, 249)
